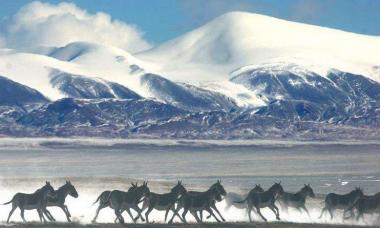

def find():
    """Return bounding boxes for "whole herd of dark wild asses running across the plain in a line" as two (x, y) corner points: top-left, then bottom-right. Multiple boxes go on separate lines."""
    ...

(4, 181), (380, 223)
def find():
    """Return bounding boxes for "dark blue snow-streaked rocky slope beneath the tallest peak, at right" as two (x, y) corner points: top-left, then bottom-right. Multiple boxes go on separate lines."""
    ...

(231, 65), (380, 123)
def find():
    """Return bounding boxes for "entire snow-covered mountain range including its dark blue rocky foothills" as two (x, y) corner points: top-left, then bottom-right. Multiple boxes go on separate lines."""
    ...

(0, 12), (380, 138)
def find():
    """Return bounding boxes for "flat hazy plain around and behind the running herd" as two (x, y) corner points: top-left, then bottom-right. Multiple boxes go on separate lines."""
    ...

(0, 139), (380, 225)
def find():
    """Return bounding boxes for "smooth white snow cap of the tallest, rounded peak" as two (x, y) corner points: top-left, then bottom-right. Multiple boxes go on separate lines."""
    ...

(137, 12), (380, 82)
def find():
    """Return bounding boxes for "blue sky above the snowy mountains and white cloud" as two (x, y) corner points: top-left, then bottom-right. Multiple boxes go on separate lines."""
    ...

(0, 0), (380, 43)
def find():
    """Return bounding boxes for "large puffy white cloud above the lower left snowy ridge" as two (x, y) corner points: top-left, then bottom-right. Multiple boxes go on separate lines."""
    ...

(0, 2), (151, 53)
